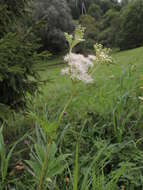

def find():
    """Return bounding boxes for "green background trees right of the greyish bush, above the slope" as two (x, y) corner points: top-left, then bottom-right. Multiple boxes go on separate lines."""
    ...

(68, 0), (143, 50)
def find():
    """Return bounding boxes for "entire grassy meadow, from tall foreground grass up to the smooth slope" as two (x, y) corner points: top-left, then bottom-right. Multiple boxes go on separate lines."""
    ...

(0, 47), (143, 190)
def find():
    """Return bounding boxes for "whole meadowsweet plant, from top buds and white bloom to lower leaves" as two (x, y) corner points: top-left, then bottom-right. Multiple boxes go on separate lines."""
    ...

(27, 26), (114, 190)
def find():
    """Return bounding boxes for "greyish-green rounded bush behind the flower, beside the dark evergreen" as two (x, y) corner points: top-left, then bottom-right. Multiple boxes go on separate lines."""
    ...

(34, 0), (73, 52)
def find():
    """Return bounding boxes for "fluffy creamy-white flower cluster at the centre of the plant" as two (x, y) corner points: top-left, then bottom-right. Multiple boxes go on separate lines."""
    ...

(62, 53), (95, 84)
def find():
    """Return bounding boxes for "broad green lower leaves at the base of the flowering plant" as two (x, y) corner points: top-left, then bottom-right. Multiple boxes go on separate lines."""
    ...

(26, 126), (68, 190)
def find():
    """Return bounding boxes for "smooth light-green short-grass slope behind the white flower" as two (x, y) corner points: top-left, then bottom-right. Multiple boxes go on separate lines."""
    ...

(36, 48), (143, 122)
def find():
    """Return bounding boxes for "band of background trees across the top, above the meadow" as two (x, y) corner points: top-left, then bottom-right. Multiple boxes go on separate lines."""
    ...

(0, 0), (143, 53)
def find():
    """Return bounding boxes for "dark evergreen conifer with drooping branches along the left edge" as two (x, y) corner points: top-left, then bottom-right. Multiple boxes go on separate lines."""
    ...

(0, 0), (43, 120)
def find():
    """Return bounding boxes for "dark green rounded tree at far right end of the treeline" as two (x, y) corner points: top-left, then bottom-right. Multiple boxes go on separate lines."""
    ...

(118, 0), (143, 49)
